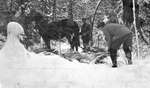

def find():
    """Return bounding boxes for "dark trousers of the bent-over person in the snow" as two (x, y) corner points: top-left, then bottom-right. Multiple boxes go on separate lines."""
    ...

(109, 33), (132, 67)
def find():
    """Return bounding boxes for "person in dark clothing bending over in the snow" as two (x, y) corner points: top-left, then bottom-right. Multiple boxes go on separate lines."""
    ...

(98, 23), (132, 67)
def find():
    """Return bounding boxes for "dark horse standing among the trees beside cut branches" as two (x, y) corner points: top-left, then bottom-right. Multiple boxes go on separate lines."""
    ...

(29, 11), (80, 51)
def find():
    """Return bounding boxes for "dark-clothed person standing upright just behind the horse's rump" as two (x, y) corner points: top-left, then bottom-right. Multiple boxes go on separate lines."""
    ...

(81, 18), (92, 51)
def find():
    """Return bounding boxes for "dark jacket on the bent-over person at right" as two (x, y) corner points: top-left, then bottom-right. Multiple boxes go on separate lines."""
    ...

(102, 23), (131, 48)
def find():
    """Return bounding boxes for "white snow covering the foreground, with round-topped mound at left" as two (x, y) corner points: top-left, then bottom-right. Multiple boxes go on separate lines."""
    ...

(0, 23), (150, 88)
